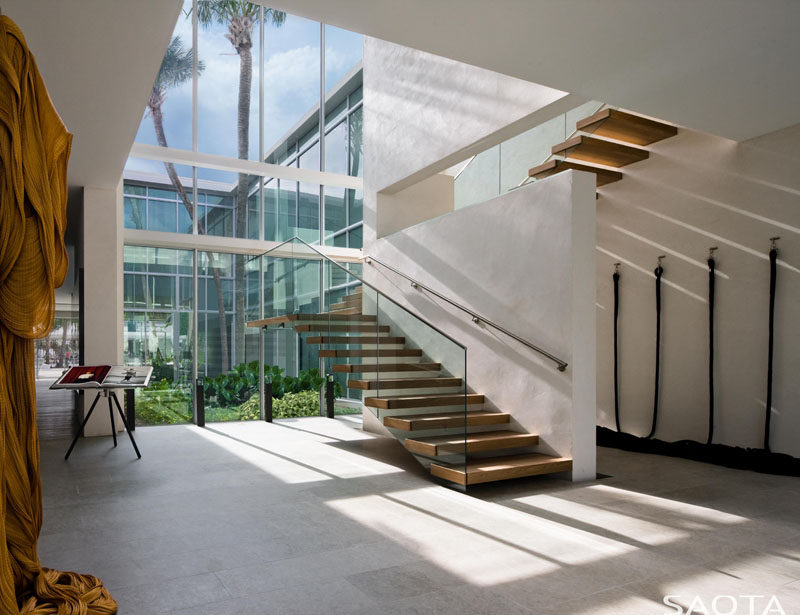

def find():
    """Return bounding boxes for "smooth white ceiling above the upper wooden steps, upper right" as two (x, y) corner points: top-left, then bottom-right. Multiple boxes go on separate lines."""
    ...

(265, 0), (800, 141)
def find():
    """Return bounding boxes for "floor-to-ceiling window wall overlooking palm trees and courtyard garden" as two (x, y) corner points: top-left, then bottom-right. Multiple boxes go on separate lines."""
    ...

(123, 0), (363, 423)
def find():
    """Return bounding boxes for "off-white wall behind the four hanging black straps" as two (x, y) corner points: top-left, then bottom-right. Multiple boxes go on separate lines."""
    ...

(597, 126), (800, 456)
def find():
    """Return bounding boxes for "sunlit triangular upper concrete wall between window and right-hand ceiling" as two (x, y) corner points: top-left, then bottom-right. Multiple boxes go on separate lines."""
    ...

(363, 38), (585, 244)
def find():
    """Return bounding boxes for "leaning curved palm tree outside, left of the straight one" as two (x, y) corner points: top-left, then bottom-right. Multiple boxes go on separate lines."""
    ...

(147, 36), (230, 371)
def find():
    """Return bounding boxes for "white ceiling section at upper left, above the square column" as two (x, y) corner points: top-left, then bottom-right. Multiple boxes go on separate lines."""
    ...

(0, 0), (182, 188)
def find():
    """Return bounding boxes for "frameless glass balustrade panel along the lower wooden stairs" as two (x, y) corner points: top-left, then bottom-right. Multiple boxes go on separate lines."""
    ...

(262, 240), (468, 470)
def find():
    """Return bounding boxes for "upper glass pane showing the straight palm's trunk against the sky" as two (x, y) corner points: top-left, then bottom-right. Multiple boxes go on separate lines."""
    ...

(198, 1), (262, 160)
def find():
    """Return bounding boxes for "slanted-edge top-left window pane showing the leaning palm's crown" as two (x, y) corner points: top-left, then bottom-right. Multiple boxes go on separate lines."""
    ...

(136, 0), (192, 150)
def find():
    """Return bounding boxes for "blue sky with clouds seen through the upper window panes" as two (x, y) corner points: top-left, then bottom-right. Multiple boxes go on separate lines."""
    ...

(127, 0), (363, 181)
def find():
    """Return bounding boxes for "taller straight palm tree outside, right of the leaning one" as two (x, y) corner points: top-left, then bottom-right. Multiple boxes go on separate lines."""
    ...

(197, 0), (286, 363)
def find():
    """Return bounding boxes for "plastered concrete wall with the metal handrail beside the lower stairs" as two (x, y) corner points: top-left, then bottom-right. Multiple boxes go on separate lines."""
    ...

(364, 173), (595, 479)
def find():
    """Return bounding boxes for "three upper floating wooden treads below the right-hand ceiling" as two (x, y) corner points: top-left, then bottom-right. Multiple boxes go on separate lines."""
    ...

(528, 109), (678, 188)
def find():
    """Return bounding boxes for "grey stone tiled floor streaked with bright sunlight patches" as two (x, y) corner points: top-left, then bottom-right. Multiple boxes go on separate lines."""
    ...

(39, 418), (800, 615)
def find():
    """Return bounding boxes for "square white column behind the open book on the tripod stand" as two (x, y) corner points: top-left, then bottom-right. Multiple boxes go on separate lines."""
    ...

(81, 181), (123, 436)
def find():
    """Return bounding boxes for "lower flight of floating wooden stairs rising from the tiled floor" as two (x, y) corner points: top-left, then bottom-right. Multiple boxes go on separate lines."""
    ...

(248, 287), (572, 487)
